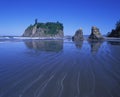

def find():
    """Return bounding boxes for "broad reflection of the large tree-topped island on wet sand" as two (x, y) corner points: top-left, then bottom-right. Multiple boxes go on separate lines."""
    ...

(24, 40), (63, 52)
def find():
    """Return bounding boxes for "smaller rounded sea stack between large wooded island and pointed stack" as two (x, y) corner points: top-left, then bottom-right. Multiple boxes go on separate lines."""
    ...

(72, 29), (84, 41)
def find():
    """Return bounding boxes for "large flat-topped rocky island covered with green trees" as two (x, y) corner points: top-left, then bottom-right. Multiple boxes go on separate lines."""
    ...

(22, 22), (64, 37)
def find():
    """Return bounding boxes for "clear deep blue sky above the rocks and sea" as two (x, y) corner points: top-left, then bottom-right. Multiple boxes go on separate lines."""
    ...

(0, 0), (120, 35)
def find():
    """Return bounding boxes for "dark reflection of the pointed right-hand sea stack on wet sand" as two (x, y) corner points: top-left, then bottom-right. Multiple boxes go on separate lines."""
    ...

(88, 41), (103, 53)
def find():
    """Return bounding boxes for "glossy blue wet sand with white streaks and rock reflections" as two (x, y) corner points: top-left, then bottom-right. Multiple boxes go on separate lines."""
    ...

(0, 40), (120, 97)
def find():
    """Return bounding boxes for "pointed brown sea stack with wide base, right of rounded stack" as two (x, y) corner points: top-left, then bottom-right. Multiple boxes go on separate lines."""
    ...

(89, 26), (103, 40)
